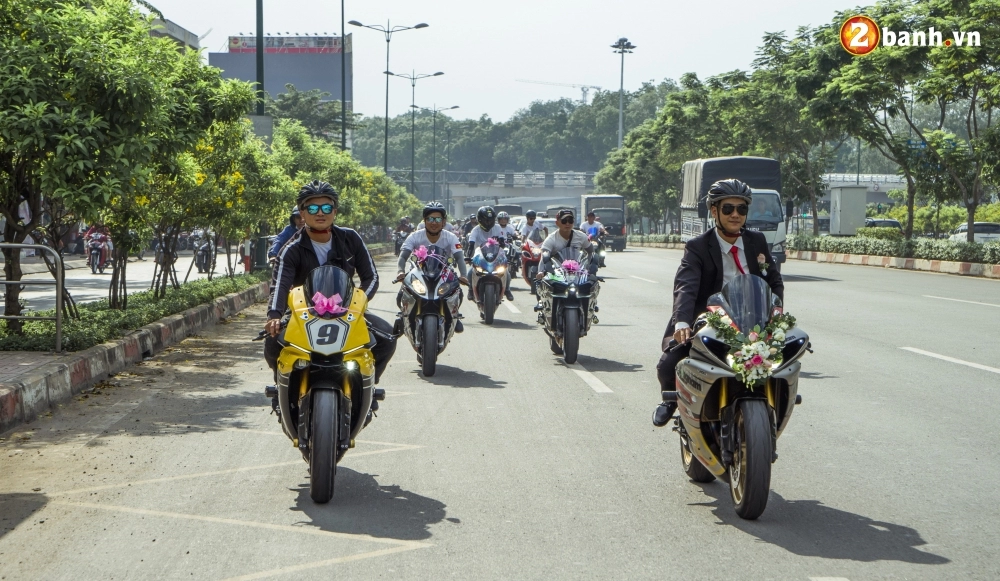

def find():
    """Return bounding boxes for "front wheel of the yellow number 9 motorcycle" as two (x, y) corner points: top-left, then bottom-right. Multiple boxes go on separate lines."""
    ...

(309, 389), (340, 504)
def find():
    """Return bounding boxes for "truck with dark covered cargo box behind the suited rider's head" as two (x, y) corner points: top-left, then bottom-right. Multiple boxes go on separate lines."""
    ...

(681, 156), (786, 272)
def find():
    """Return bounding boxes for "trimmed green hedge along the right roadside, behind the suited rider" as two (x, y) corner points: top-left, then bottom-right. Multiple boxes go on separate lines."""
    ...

(788, 233), (1000, 264)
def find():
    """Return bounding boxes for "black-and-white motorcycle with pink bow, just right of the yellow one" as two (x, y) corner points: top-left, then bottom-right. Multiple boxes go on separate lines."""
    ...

(399, 246), (462, 377)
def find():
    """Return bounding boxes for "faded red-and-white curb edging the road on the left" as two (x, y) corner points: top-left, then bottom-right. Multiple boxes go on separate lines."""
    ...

(0, 282), (269, 434)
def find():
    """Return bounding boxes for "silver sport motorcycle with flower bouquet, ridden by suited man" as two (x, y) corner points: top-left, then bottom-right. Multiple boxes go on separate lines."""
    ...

(663, 275), (811, 520)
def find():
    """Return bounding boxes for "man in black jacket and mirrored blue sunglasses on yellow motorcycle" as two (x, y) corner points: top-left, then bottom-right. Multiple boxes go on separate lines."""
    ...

(264, 180), (396, 383)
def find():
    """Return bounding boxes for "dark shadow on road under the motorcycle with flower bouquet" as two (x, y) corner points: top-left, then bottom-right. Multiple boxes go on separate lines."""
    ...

(697, 481), (951, 565)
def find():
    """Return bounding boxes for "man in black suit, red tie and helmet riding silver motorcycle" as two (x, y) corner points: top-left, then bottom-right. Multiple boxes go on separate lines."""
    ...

(653, 179), (785, 427)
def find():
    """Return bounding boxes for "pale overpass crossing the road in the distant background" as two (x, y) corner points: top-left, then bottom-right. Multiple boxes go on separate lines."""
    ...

(389, 169), (906, 216)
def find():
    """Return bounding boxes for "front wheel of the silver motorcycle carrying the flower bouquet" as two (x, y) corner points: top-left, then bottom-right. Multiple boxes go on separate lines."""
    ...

(729, 399), (774, 520)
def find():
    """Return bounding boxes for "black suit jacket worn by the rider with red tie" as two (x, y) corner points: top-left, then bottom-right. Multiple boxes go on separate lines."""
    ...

(663, 228), (785, 345)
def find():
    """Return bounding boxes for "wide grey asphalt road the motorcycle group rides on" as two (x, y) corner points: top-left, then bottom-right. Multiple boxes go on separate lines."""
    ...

(0, 249), (1000, 580)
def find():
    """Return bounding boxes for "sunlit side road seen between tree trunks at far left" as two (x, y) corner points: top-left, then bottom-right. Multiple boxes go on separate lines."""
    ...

(10, 252), (236, 311)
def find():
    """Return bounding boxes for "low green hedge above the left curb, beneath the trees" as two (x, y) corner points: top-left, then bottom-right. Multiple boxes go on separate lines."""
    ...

(0, 270), (271, 351)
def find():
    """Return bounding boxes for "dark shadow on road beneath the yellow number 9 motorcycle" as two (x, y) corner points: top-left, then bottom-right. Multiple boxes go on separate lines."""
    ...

(291, 466), (446, 541)
